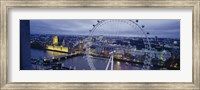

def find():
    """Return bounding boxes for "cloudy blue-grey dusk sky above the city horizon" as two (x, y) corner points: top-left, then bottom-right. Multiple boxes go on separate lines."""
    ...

(30, 19), (180, 38)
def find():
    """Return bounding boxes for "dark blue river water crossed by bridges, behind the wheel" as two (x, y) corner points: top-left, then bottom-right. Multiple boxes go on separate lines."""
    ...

(31, 49), (145, 70)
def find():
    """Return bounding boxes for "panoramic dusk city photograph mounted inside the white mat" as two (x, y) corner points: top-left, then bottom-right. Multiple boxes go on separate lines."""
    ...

(20, 19), (180, 70)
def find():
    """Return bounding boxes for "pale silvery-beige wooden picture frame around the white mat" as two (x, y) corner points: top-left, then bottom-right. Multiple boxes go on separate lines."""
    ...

(0, 0), (200, 90)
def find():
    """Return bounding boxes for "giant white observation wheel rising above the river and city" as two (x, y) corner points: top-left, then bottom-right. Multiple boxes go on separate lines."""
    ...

(85, 19), (152, 70)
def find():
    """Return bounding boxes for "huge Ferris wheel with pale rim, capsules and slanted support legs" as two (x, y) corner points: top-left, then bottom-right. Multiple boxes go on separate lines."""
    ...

(85, 19), (152, 70)
